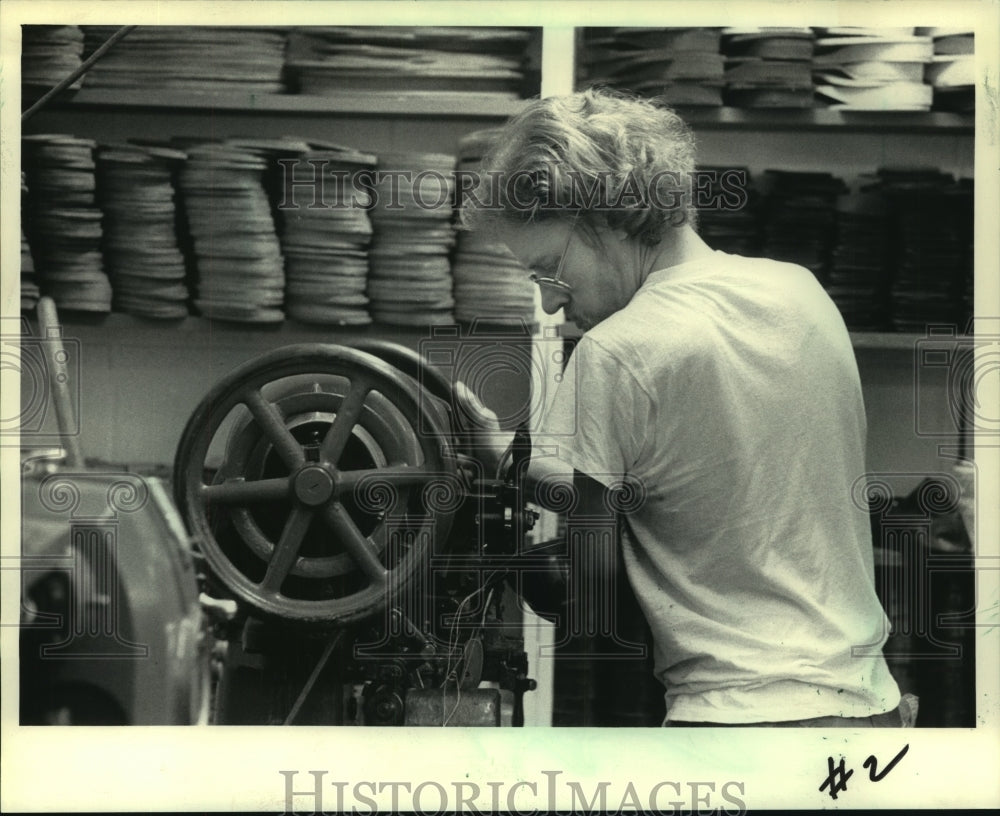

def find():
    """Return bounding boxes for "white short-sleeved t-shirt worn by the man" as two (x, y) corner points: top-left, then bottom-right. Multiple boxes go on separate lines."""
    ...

(539, 252), (900, 723)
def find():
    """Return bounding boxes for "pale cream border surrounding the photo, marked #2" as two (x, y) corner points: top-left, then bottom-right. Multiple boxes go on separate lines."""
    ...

(0, 0), (1000, 812)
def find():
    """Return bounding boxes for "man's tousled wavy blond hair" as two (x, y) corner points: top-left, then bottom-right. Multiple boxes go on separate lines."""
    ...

(462, 88), (696, 245)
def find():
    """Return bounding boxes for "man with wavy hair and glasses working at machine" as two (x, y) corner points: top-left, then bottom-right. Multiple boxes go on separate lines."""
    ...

(464, 91), (913, 727)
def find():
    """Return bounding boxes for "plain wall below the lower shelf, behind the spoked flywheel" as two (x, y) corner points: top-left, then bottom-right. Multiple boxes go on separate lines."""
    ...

(22, 315), (530, 465)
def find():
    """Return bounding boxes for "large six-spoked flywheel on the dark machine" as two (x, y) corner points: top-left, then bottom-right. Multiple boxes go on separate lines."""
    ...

(174, 344), (461, 624)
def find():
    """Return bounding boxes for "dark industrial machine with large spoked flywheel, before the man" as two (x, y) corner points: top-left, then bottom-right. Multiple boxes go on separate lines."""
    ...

(174, 340), (558, 726)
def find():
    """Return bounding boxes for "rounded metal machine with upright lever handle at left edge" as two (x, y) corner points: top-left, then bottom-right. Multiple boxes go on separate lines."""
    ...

(12, 298), (212, 725)
